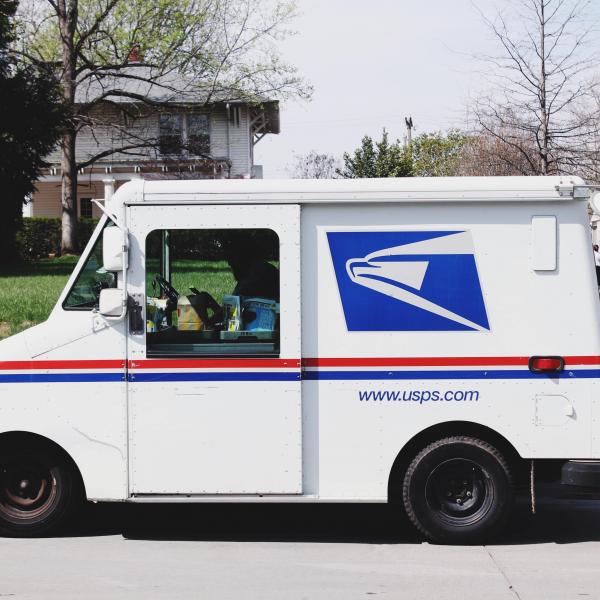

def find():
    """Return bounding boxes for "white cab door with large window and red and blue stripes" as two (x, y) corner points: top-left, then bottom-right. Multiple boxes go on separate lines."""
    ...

(128, 205), (302, 495)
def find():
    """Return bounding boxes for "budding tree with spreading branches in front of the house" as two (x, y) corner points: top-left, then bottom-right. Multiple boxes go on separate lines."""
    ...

(16, 0), (311, 253)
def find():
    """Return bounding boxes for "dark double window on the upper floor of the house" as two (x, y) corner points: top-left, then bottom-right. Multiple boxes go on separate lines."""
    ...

(159, 113), (210, 155)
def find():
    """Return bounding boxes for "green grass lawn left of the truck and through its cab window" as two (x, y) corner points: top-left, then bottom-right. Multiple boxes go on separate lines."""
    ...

(0, 256), (235, 339)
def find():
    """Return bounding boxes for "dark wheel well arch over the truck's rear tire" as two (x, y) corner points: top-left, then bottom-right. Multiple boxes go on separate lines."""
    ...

(388, 421), (527, 502)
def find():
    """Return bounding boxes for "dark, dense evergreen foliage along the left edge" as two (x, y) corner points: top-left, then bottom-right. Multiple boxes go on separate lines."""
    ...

(0, 0), (64, 264)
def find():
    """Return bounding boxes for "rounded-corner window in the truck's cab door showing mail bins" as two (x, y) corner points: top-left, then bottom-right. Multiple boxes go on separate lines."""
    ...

(146, 229), (280, 357)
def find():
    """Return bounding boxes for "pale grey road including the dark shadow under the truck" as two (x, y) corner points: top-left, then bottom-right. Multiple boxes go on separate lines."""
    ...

(0, 490), (600, 600)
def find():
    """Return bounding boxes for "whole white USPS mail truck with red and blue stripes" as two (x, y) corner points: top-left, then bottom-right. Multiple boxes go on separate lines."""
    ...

(0, 177), (600, 542)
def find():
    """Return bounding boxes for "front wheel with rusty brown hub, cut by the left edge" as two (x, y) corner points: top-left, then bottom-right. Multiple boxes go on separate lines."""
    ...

(0, 441), (80, 537)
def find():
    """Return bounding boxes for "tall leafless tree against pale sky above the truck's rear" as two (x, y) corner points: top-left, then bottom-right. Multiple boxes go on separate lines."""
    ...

(471, 0), (600, 175)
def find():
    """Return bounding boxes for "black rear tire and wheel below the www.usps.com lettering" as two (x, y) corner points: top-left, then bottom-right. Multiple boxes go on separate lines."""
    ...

(402, 436), (514, 544)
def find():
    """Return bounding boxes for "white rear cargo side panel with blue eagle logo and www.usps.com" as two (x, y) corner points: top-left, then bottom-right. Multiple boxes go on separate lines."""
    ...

(302, 201), (600, 499)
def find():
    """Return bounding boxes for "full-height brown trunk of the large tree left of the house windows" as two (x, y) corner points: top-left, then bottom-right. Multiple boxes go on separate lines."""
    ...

(57, 0), (78, 254)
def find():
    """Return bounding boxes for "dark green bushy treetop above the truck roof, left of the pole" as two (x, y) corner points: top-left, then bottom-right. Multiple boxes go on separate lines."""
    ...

(338, 129), (413, 179)
